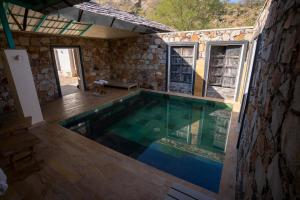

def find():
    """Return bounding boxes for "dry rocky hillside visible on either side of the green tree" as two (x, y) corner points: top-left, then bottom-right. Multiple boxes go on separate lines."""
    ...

(95, 0), (261, 28)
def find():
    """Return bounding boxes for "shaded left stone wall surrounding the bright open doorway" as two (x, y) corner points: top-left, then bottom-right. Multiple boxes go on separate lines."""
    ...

(0, 32), (110, 113)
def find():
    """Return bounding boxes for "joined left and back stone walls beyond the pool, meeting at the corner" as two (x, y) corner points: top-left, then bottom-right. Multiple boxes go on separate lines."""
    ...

(0, 27), (252, 113)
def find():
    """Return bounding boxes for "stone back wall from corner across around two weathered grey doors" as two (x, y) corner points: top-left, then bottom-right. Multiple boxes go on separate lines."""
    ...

(110, 27), (253, 96)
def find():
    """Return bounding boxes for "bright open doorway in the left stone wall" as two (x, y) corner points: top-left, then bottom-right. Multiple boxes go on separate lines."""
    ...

(52, 47), (85, 96)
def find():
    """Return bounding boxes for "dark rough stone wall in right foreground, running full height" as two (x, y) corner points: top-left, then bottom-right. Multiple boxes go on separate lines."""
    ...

(236, 0), (300, 200)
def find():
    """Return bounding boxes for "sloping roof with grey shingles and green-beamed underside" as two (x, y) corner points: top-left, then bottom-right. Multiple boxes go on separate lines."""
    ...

(0, 0), (173, 48)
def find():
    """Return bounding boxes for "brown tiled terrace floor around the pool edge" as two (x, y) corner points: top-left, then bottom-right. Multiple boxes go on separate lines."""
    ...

(0, 89), (237, 200)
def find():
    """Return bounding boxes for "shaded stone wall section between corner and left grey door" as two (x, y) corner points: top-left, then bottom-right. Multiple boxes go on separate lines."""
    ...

(110, 35), (167, 90)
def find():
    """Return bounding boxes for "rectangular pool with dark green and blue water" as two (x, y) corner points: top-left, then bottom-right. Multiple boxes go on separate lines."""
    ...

(61, 91), (232, 192)
